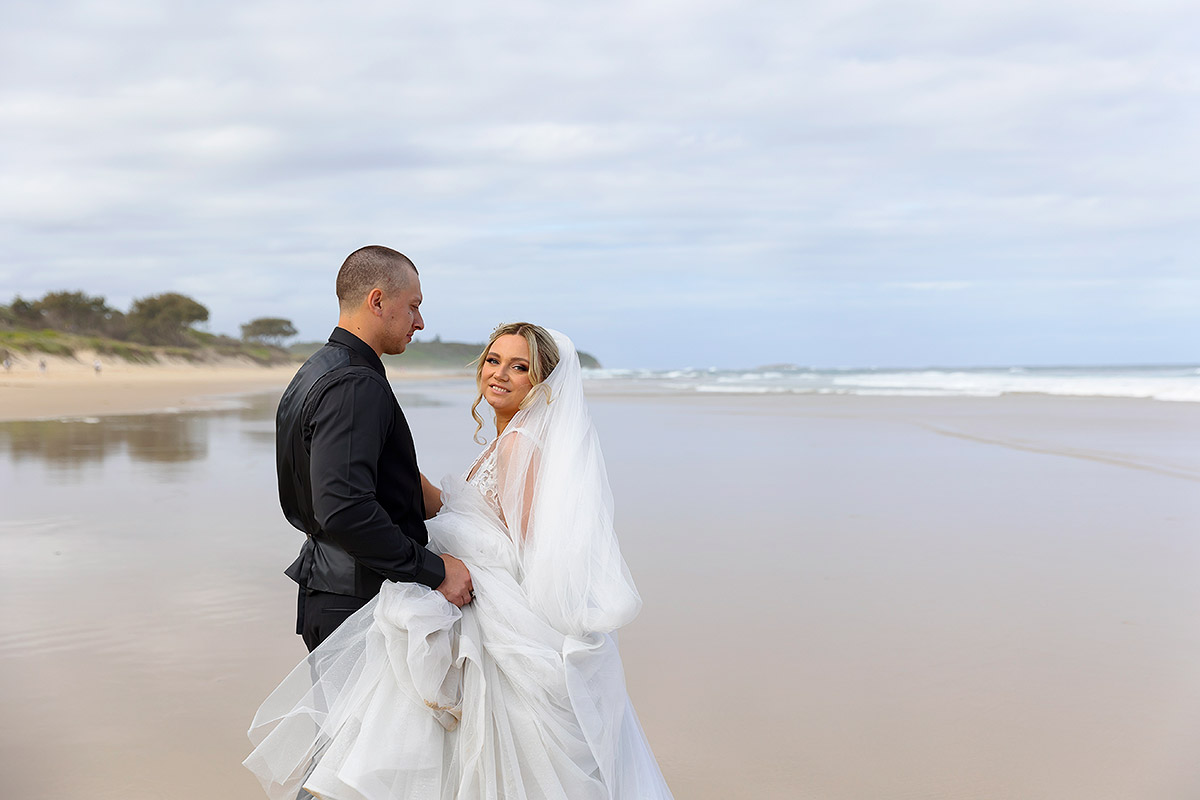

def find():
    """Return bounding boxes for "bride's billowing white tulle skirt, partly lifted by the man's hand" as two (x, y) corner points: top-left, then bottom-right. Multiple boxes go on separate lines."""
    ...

(245, 483), (671, 800)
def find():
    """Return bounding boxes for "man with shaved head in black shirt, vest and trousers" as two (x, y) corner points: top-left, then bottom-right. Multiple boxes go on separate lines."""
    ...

(275, 245), (472, 651)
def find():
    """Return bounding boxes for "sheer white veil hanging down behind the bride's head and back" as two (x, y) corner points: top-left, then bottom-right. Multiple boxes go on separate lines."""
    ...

(497, 331), (642, 636)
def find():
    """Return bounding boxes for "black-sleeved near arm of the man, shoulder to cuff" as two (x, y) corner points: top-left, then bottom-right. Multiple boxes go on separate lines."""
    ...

(310, 374), (446, 588)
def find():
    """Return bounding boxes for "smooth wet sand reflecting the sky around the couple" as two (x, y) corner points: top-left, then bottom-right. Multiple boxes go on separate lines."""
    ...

(0, 380), (1200, 800)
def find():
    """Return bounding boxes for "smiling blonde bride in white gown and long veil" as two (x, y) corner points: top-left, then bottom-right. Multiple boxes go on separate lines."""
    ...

(245, 323), (671, 800)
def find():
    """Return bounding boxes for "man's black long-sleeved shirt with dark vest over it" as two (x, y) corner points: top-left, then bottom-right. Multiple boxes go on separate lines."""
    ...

(275, 327), (445, 599)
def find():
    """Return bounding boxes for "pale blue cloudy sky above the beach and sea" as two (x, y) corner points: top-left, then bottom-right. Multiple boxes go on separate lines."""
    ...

(0, 0), (1200, 367)
